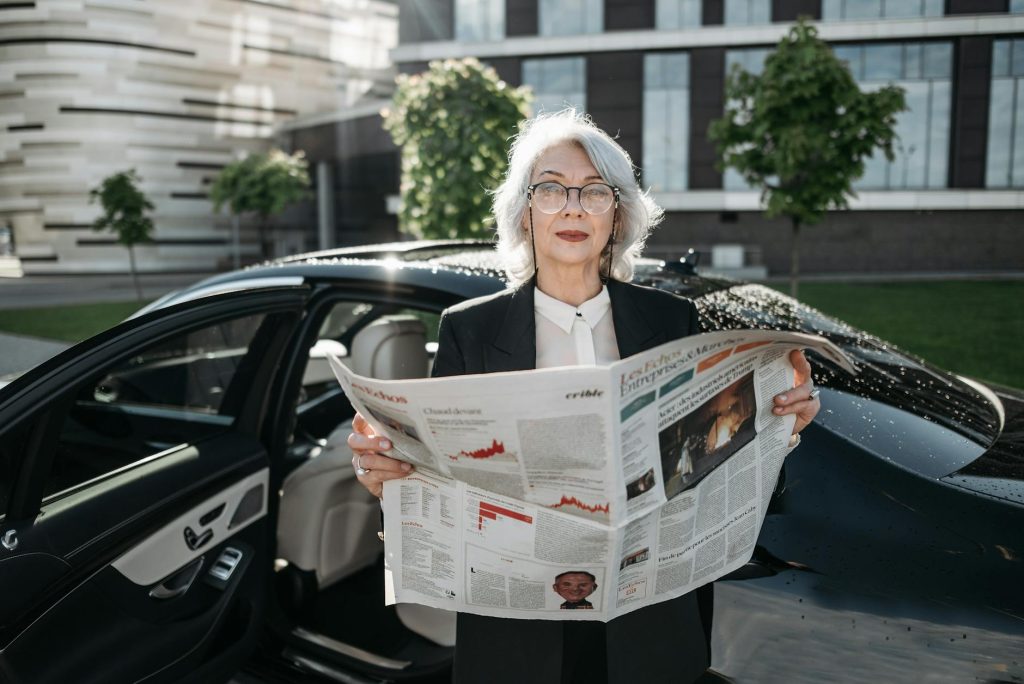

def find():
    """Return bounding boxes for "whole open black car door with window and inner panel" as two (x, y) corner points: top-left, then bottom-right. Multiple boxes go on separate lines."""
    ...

(0, 287), (308, 684)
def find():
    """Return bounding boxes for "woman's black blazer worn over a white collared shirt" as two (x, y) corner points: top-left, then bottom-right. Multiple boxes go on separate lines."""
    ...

(433, 281), (713, 684)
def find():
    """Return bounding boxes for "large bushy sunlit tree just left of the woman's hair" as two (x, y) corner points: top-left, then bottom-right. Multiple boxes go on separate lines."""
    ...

(383, 58), (529, 238)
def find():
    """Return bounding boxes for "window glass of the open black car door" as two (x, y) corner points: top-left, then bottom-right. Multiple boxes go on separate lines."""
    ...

(43, 314), (273, 497)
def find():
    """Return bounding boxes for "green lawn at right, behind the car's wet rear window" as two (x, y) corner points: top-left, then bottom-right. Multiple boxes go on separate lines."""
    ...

(773, 281), (1024, 388)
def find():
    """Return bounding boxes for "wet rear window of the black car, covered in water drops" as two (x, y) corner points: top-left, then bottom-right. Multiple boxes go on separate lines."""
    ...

(636, 270), (999, 447)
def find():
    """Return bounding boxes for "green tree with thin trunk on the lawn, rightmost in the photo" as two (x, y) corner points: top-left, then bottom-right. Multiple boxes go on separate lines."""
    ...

(708, 18), (906, 297)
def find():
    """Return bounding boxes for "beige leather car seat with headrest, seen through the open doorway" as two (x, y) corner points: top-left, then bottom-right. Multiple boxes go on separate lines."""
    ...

(278, 315), (456, 646)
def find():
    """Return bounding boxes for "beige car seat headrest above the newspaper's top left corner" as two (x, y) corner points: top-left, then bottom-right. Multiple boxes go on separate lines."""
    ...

(351, 314), (428, 380)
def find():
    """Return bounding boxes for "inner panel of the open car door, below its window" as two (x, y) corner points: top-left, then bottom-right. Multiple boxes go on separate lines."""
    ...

(0, 434), (268, 683)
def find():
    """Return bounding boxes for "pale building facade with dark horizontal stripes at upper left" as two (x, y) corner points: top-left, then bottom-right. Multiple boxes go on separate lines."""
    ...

(0, 0), (397, 272)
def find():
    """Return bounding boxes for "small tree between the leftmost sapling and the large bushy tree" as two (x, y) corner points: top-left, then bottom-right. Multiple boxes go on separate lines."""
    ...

(210, 149), (309, 268)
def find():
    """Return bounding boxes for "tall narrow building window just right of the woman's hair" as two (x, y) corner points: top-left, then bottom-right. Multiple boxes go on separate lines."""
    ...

(643, 52), (690, 193)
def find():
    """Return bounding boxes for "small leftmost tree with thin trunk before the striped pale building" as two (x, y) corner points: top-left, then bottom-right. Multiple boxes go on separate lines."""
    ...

(89, 169), (154, 301)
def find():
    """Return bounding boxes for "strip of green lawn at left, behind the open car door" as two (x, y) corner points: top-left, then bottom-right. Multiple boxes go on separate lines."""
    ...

(0, 302), (145, 342)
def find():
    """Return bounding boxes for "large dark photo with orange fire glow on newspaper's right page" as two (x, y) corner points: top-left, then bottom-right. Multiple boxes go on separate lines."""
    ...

(658, 371), (757, 500)
